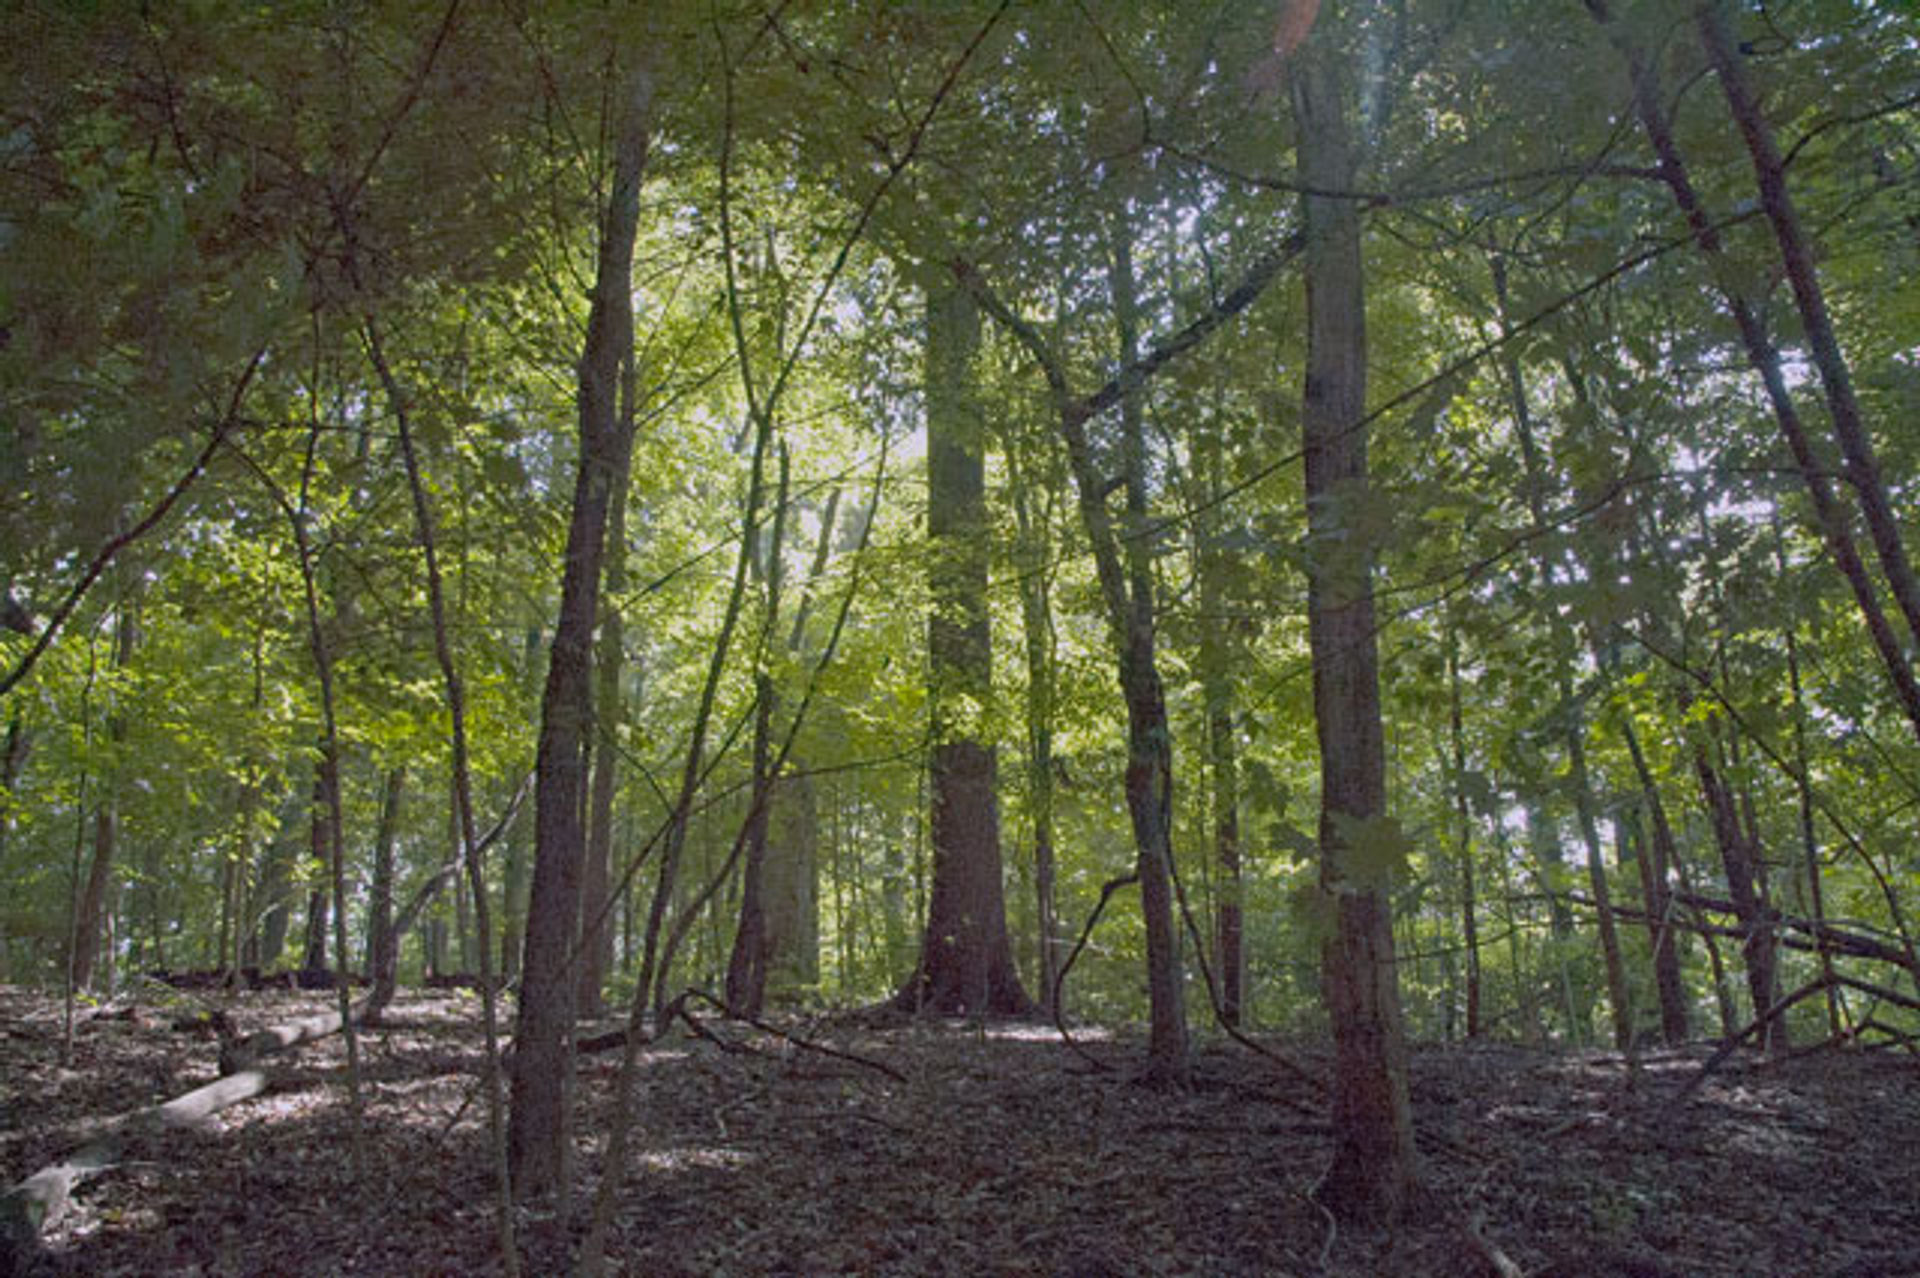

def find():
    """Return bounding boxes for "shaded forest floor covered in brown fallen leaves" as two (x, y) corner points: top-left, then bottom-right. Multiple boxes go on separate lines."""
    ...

(0, 986), (1920, 1278)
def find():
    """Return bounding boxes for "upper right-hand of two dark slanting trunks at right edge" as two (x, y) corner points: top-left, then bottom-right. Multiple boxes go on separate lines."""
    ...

(1695, 0), (1920, 641)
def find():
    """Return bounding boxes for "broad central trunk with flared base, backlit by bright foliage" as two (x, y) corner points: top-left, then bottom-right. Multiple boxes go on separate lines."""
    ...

(895, 286), (1033, 1015)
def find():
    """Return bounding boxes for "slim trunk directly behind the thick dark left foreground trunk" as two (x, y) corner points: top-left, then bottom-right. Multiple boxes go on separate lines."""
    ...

(580, 366), (634, 1017)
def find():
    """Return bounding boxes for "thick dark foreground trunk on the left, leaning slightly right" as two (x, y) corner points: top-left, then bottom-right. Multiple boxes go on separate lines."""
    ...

(507, 67), (653, 1203)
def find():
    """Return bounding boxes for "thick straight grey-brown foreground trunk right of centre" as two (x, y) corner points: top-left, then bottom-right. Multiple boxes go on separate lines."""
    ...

(1292, 34), (1417, 1220)
